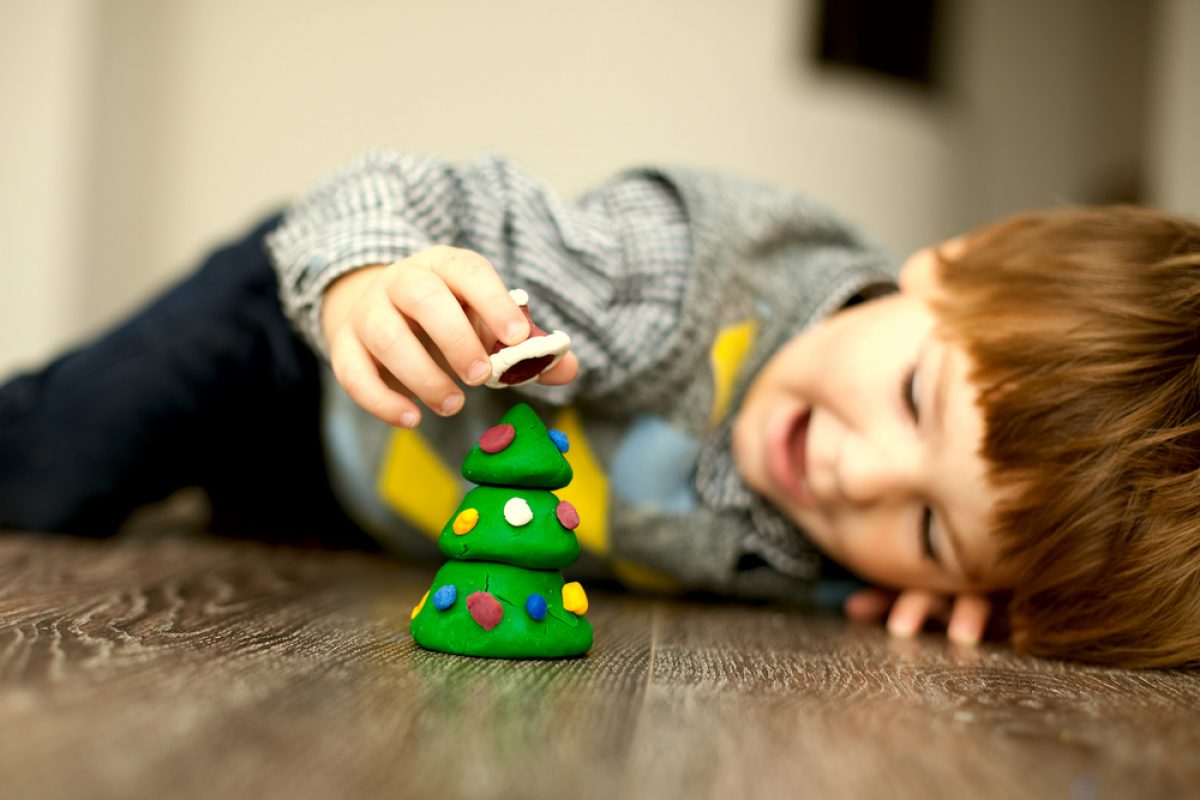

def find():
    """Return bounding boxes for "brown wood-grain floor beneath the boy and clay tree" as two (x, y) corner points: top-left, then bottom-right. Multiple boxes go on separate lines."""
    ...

(0, 534), (1200, 800)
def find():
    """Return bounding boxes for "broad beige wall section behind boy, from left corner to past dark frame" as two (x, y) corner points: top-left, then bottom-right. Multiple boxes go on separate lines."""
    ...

(75, 0), (950, 328)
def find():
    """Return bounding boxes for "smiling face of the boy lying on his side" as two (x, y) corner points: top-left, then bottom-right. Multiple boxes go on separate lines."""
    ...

(733, 251), (1010, 593)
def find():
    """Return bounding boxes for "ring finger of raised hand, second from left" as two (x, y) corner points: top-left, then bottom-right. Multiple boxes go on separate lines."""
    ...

(354, 286), (463, 416)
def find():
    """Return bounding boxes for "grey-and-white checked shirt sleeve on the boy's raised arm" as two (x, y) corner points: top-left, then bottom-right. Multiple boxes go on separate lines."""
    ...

(266, 152), (692, 402)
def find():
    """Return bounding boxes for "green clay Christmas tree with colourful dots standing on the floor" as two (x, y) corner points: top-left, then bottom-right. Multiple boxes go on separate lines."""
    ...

(412, 403), (592, 658)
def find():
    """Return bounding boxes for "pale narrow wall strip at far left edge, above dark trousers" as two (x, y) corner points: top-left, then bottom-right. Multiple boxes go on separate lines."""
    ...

(0, 0), (95, 375)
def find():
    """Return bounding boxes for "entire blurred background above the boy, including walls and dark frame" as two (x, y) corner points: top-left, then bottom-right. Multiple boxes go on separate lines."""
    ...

(0, 0), (1200, 375)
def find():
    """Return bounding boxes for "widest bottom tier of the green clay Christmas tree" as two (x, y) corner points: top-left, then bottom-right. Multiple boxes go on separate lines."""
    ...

(412, 561), (592, 658)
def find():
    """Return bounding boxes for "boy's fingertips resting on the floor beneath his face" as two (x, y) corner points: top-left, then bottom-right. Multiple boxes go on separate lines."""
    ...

(844, 588), (991, 644)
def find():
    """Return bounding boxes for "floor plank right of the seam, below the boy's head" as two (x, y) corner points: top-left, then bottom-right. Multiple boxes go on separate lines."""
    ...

(629, 606), (1200, 798)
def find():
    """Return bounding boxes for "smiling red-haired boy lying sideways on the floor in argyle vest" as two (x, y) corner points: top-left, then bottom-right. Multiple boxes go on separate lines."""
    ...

(0, 154), (1200, 666)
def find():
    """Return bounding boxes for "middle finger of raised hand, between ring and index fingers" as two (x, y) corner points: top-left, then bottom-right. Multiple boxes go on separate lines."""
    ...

(388, 270), (494, 388)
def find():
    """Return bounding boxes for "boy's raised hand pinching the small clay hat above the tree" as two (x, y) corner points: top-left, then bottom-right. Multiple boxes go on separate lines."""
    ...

(320, 246), (578, 428)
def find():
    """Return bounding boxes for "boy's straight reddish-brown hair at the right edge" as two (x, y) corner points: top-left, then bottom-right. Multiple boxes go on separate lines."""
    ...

(936, 207), (1200, 667)
